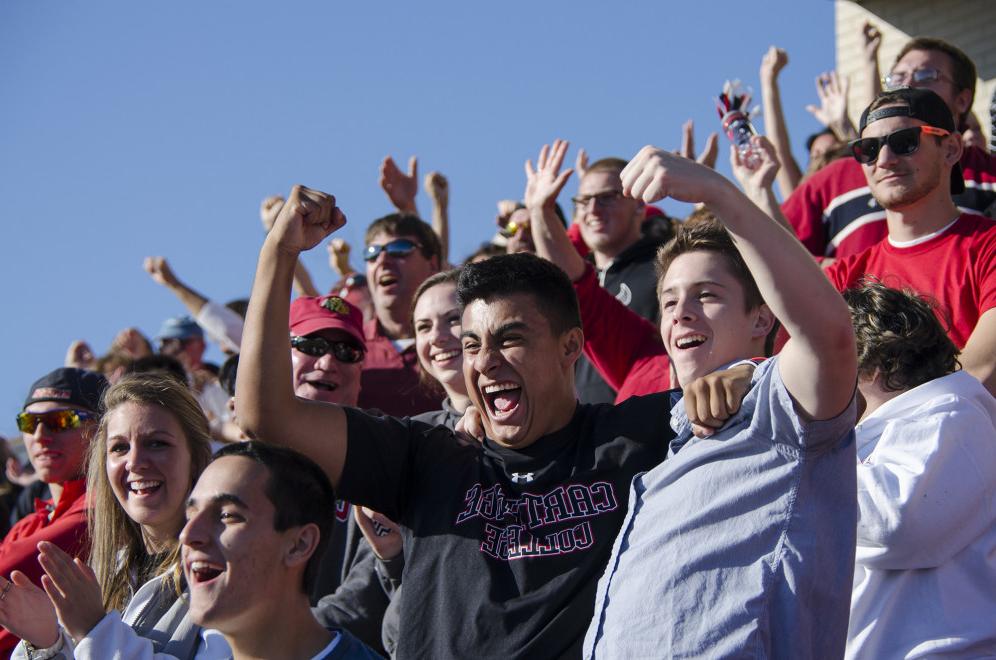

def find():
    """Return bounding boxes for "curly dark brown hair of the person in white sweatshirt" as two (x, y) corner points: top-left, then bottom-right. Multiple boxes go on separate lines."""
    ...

(844, 278), (960, 392)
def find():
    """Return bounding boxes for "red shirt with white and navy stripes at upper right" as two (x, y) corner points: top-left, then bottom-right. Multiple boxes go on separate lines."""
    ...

(782, 147), (996, 259)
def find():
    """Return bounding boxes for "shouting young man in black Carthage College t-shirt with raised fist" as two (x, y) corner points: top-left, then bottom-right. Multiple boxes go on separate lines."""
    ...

(237, 187), (736, 657)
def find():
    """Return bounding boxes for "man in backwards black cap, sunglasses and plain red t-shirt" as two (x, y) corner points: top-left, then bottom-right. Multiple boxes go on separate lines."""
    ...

(827, 88), (996, 392)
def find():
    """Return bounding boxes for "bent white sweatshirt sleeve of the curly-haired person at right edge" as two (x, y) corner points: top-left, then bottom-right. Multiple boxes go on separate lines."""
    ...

(857, 398), (996, 570)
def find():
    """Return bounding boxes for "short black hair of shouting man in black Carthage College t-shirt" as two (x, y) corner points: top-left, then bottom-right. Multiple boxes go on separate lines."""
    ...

(457, 252), (581, 335)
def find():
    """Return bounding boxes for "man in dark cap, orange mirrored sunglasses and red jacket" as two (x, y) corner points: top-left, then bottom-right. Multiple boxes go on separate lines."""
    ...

(0, 367), (107, 658)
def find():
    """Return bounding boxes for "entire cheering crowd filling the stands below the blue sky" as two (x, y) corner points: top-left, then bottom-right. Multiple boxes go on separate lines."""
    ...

(0, 25), (996, 660)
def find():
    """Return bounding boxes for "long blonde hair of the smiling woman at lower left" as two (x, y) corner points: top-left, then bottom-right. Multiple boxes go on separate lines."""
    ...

(86, 373), (211, 610)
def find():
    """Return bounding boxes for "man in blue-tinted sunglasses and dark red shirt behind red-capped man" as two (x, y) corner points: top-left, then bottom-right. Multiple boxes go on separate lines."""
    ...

(360, 213), (441, 415)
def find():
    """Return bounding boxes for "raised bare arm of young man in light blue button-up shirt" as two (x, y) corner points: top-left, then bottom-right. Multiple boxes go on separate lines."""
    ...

(622, 146), (857, 419)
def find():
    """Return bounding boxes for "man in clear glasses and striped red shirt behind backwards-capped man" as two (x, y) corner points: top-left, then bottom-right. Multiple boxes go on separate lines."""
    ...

(782, 37), (996, 259)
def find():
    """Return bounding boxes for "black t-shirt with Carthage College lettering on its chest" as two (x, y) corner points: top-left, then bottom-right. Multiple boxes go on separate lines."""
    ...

(339, 394), (673, 658)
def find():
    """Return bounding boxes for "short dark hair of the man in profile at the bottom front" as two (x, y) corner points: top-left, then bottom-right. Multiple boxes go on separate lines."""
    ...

(214, 440), (335, 594)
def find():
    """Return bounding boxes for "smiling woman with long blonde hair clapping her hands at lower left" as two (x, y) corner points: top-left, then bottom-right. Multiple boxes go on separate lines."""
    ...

(3, 374), (230, 658)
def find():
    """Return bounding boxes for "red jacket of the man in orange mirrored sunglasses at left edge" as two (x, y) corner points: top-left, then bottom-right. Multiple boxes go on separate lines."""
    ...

(0, 479), (87, 658)
